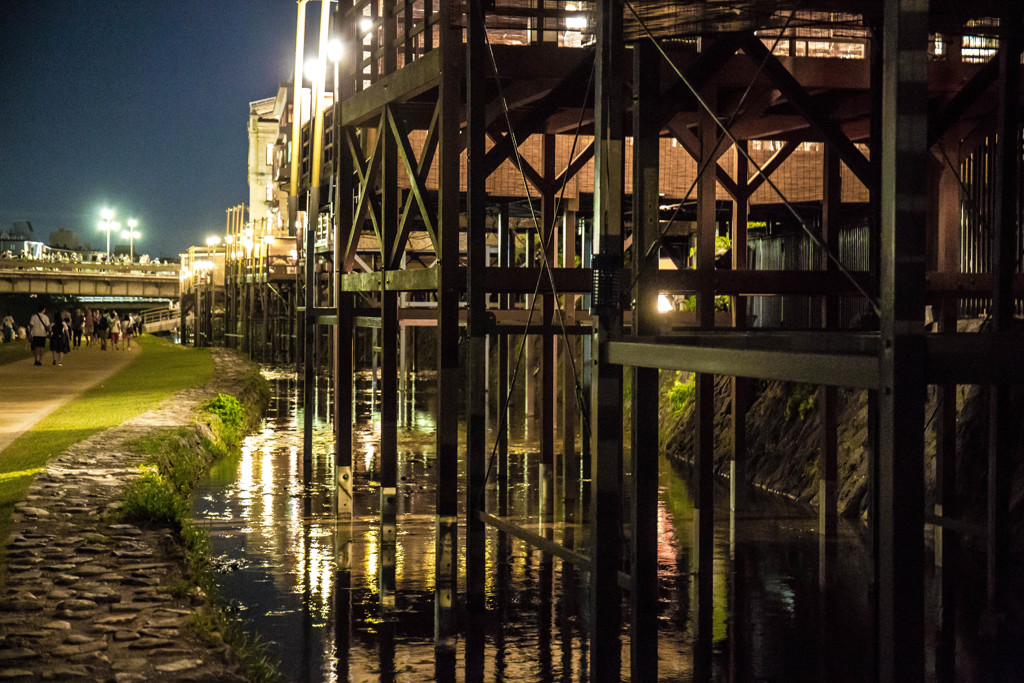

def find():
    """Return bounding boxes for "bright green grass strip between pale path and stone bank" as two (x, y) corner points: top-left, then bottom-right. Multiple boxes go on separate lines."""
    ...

(0, 335), (213, 539)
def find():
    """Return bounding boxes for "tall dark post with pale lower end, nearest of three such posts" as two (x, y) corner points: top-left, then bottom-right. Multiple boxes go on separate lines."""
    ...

(434, 10), (463, 659)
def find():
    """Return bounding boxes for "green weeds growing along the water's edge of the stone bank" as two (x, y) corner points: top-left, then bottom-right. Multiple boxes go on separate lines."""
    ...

(121, 392), (280, 681)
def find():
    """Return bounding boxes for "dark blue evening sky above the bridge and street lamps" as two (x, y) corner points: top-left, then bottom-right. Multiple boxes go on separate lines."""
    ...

(0, 0), (305, 257)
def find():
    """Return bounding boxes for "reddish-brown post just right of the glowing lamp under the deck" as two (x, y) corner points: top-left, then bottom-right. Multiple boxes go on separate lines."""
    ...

(693, 80), (718, 677)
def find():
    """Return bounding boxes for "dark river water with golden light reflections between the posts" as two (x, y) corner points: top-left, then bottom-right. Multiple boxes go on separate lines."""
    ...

(195, 371), (869, 681)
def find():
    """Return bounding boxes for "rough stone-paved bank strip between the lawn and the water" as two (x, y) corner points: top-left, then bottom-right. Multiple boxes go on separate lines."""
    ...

(0, 349), (253, 682)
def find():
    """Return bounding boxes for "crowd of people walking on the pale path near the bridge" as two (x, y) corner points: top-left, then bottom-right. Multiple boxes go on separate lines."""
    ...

(22, 305), (142, 366)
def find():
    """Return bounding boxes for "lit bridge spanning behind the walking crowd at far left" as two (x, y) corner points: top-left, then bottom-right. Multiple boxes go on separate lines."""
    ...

(0, 258), (181, 299)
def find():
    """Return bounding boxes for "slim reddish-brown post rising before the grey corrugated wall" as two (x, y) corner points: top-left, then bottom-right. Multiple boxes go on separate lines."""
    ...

(818, 143), (843, 590)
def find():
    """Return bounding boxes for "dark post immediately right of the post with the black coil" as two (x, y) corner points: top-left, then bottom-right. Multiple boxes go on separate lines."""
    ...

(630, 41), (660, 681)
